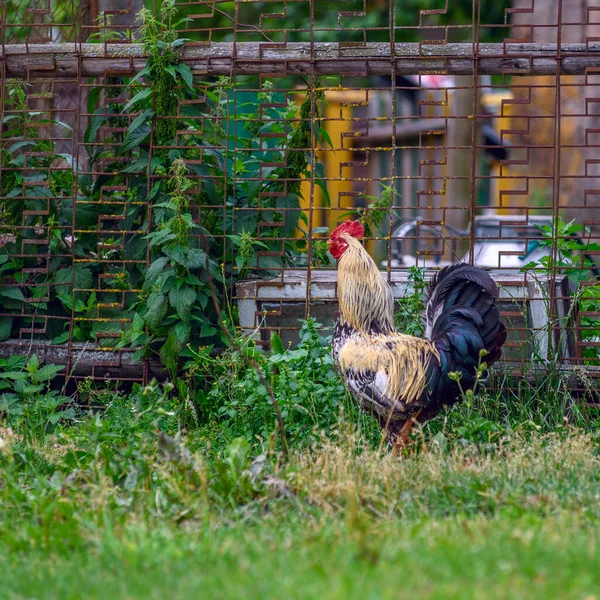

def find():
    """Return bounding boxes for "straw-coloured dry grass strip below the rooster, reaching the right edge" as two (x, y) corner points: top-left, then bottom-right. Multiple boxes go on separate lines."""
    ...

(286, 430), (600, 519)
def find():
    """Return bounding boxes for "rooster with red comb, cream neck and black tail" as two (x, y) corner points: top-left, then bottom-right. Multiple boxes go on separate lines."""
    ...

(328, 221), (506, 451)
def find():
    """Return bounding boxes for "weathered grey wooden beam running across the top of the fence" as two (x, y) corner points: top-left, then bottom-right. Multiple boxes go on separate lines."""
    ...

(0, 42), (600, 78)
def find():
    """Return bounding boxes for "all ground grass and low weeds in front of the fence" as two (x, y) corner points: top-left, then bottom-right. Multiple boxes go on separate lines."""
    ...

(0, 322), (600, 600)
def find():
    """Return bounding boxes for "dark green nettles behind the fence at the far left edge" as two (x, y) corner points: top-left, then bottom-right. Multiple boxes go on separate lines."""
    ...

(0, 79), (75, 341)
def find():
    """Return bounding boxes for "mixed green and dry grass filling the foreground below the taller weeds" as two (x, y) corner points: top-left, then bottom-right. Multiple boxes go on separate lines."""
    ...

(0, 418), (600, 599)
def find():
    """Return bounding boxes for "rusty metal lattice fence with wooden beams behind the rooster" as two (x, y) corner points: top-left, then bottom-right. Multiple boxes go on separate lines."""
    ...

(0, 0), (600, 390)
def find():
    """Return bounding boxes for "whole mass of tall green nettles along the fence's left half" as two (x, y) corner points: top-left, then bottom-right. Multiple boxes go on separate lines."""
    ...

(0, 0), (328, 378)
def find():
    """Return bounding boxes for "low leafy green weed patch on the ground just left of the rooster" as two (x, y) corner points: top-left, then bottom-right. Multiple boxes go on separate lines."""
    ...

(187, 319), (379, 448)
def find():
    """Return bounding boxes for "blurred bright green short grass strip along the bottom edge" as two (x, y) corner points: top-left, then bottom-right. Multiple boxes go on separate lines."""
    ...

(0, 514), (600, 599)
